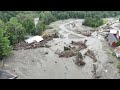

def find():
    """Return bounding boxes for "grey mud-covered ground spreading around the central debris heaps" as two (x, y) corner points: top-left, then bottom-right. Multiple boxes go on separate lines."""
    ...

(1, 19), (120, 79)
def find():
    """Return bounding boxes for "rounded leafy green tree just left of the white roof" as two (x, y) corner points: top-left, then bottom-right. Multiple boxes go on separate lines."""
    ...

(6, 17), (26, 45)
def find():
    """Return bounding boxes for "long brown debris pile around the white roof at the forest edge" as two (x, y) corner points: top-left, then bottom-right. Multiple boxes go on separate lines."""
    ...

(13, 32), (59, 50)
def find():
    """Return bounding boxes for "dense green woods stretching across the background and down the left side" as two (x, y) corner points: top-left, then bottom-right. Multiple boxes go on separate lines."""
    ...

(0, 11), (120, 59)
